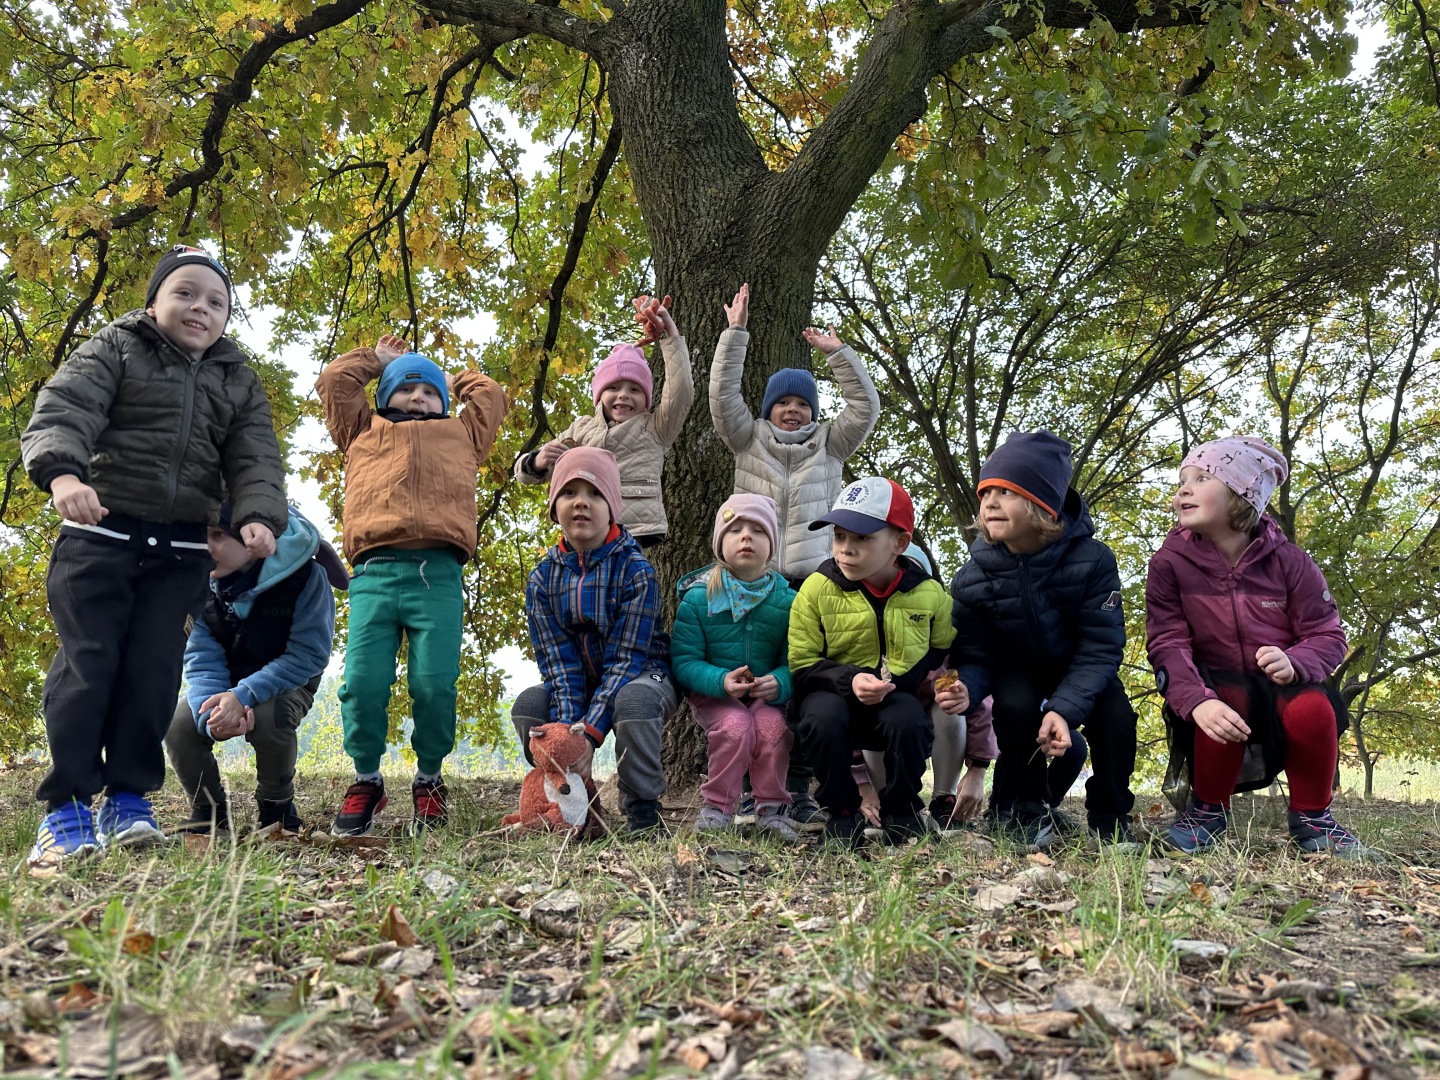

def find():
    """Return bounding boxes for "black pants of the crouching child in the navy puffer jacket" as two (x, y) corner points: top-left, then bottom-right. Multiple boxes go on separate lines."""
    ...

(991, 668), (1136, 831)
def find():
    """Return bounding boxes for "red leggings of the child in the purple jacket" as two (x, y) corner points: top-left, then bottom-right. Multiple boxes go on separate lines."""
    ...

(1192, 685), (1339, 812)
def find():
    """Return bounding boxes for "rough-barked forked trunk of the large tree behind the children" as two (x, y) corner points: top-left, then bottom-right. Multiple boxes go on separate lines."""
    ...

(419, 0), (1204, 782)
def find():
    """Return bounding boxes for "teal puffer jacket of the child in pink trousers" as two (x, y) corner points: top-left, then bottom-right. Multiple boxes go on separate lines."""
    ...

(670, 566), (795, 706)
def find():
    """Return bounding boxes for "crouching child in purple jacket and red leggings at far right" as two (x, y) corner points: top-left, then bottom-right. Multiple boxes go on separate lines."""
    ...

(1145, 438), (1369, 860)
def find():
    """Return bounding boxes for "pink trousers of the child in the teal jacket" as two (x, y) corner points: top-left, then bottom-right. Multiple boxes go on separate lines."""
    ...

(690, 694), (793, 814)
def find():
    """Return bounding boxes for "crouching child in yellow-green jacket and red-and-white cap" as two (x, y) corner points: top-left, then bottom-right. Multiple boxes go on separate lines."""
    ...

(791, 477), (955, 845)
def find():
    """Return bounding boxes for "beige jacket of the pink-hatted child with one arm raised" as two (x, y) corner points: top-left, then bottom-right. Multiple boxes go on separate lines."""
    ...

(516, 337), (696, 539)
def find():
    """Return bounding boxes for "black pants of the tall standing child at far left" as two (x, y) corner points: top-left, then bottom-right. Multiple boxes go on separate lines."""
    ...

(35, 530), (215, 809)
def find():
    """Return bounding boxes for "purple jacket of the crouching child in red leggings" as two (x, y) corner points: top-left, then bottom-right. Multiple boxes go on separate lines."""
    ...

(1145, 517), (1346, 720)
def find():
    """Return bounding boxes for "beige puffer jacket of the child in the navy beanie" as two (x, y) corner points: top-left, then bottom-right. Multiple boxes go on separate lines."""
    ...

(710, 327), (880, 577)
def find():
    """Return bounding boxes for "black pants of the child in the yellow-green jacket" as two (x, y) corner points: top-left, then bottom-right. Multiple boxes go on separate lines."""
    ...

(796, 690), (935, 815)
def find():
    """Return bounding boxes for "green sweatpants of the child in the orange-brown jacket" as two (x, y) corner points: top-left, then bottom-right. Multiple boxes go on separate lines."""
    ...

(340, 547), (465, 773)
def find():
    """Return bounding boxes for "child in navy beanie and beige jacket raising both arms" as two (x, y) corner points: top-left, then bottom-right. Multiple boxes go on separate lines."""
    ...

(710, 284), (880, 825)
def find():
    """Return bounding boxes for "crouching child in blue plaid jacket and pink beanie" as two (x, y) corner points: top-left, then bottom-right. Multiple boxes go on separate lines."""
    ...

(511, 446), (677, 835)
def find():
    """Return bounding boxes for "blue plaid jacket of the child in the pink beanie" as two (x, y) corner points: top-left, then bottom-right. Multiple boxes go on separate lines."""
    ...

(526, 527), (670, 743)
